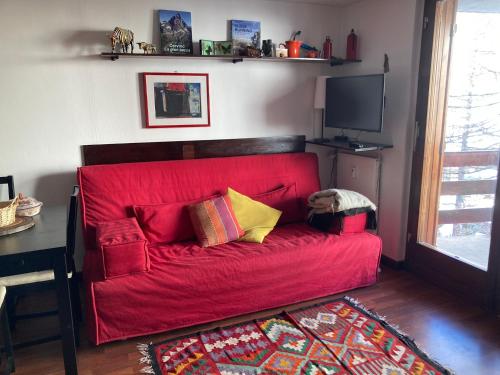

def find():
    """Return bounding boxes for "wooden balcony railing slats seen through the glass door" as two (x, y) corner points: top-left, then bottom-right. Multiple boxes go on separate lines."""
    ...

(438, 151), (500, 224)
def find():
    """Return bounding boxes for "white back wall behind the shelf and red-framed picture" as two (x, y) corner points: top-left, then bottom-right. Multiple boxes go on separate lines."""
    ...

(0, 0), (339, 204)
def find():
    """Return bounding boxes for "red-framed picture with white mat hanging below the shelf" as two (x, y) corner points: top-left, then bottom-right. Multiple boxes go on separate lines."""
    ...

(143, 73), (210, 128)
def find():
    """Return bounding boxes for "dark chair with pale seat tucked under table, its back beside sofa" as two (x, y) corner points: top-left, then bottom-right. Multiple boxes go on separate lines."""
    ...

(0, 186), (82, 348)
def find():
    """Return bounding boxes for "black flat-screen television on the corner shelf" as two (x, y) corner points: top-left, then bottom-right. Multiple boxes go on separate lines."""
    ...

(325, 74), (385, 132)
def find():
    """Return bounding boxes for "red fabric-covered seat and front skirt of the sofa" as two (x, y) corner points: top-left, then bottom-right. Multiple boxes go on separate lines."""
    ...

(86, 224), (381, 344)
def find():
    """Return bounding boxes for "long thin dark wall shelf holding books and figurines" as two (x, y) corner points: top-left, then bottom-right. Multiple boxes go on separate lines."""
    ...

(100, 52), (361, 66)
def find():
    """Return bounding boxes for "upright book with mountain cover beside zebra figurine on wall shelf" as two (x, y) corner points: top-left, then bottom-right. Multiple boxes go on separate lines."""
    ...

(158, 10), (193, 55)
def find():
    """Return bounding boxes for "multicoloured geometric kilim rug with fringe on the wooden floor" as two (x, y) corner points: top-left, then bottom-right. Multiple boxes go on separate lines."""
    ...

(139, 297), (450, 375)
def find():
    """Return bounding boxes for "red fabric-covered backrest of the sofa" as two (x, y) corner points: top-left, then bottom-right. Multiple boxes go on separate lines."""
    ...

(78, 153), (320, 249)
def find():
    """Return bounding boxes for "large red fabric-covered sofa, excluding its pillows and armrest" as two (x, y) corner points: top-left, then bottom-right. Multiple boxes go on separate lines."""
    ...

(78, 153), (381, 344)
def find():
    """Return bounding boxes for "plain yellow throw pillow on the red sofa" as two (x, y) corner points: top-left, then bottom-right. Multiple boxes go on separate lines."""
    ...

(227, 188), (281, 243)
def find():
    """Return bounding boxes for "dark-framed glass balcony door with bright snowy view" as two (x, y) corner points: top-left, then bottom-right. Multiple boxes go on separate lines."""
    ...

(406, 0), (500, 304)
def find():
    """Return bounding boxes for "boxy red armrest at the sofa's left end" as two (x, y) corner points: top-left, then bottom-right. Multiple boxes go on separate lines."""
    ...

(96, 218), (150, 279)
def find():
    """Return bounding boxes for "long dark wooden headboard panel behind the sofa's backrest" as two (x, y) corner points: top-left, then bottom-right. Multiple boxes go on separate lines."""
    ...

(82, 135), (306, 165)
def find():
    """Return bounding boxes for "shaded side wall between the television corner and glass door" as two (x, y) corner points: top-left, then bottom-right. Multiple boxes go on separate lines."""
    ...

(330, 0), (423, 261)
